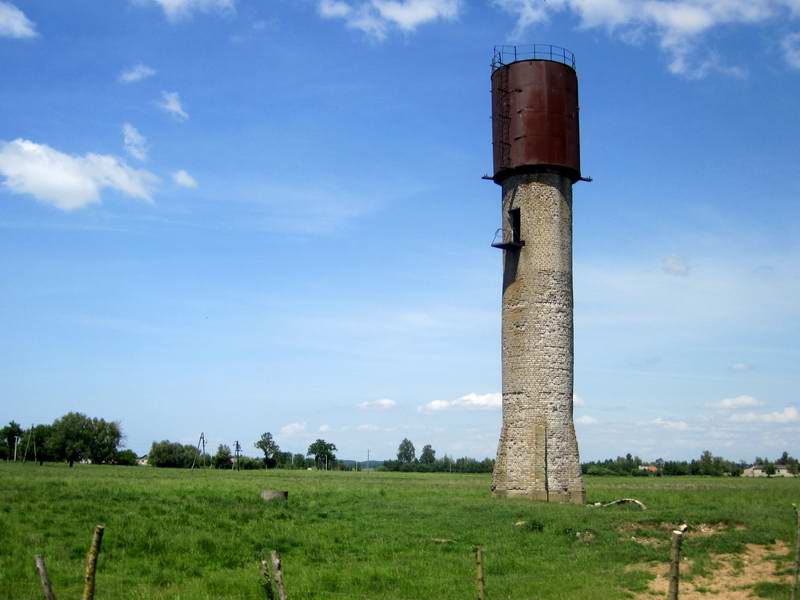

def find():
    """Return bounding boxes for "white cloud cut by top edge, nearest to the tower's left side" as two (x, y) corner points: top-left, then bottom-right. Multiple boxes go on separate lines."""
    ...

(318, 0), (461, 40)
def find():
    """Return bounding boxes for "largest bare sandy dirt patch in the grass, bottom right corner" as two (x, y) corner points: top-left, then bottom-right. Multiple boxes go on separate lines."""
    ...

(630, 542), (789, 600)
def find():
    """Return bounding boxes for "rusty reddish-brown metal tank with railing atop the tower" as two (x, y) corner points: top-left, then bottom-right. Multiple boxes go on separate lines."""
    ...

(492, 44), (581, 183)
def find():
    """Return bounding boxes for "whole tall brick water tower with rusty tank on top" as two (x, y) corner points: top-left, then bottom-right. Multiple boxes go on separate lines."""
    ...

(490, 44), (586, 503)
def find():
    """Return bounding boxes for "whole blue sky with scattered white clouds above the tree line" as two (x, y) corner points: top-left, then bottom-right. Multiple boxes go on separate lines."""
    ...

(0, 0), (800, 459)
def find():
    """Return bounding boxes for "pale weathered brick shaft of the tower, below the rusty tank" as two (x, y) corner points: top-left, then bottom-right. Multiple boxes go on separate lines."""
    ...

(492, 173), (586, 503)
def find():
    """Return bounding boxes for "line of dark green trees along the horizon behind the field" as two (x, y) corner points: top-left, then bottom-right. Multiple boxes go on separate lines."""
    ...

(0, 412), (800, 477)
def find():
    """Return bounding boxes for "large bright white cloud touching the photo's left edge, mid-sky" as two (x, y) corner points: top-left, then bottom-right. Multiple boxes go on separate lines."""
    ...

(0, 139), (158, 211)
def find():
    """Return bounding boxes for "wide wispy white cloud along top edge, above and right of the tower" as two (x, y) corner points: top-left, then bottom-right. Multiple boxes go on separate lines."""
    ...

(493, 0), (798, 79)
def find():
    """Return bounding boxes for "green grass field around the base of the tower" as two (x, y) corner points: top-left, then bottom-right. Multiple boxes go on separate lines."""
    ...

(0, 464), (800, 600)
